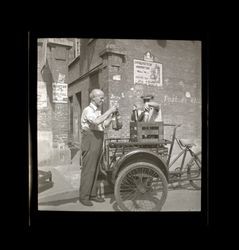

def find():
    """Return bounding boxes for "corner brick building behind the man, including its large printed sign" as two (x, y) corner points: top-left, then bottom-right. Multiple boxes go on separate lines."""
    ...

(68, 39), (201, 156)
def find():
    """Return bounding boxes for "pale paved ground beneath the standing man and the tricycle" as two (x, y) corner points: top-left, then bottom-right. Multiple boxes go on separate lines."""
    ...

(38, 166), (201, 211)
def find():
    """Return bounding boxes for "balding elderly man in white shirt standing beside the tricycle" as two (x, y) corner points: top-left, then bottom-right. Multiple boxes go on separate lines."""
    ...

(80, 89), (118, 206)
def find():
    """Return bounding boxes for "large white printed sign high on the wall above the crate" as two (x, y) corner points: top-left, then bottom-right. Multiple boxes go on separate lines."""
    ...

(134, 59), (163, 87)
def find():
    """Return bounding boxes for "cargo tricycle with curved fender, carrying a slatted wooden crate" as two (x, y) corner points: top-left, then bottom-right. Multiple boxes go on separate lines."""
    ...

(100, 122), (201, 211)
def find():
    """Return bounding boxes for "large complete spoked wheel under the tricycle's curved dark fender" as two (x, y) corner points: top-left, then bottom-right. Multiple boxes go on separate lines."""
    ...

(114, 162), (168, 211)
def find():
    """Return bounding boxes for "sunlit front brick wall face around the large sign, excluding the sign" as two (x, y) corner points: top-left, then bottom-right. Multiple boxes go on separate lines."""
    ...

(105, 40), (201, 149)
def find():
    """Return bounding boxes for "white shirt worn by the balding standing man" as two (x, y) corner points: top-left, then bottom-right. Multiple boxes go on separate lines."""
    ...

(81, 102), (104, 131)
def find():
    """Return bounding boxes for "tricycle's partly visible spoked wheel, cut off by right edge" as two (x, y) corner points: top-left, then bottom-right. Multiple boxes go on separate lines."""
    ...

(187, 152), (202, 189)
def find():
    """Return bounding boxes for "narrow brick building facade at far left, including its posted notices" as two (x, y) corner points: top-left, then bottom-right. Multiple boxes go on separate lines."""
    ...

(37, 38), (74, 165)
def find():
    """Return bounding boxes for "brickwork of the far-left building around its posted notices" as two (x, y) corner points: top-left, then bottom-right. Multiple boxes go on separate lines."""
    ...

(37, 39), (70, 165)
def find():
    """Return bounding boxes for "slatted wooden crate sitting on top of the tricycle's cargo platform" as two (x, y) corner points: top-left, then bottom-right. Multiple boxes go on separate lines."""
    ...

(130, 122), (164, 142)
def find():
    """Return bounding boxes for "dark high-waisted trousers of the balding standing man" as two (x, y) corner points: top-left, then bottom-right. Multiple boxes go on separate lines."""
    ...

(80, 130), (104, 200)
